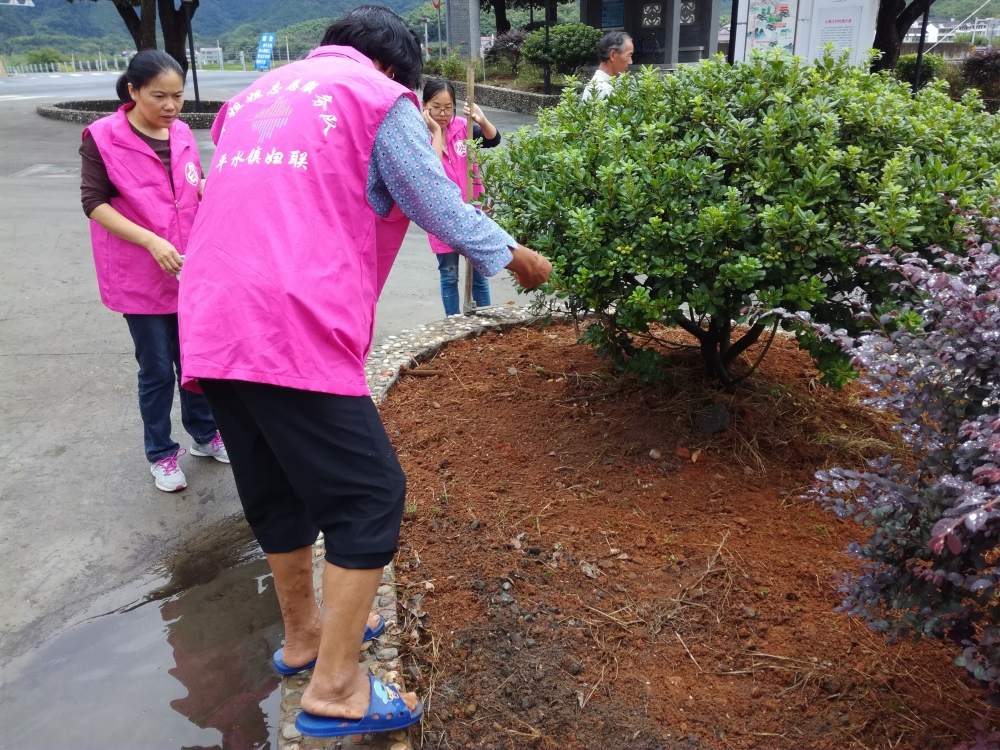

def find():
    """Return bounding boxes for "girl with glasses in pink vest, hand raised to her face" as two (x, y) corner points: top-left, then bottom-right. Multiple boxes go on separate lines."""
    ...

(423, 78), (500, 315)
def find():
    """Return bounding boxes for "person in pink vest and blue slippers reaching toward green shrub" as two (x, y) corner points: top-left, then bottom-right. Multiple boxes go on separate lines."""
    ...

(179, 5), (552, 737)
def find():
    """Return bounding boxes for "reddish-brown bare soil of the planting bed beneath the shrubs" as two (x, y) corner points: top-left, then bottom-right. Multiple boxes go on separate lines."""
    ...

(381, 326), (1000, 750)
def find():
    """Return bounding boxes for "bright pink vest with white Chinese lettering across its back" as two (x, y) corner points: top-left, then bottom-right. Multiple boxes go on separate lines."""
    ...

(179, 46), (417, 396)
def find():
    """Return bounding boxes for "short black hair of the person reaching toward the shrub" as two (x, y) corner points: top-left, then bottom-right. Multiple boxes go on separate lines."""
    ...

(322, 5), (424, 91)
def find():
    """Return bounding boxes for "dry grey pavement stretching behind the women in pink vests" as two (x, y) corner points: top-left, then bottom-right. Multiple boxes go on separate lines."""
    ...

(0, 71), (534, 682)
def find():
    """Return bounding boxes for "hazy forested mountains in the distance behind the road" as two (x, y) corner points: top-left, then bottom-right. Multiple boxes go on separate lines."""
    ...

(0, 0), (420, 54)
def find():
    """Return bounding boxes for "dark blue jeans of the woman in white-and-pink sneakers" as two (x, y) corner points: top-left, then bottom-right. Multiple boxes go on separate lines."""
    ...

(125, 313), (217, 463)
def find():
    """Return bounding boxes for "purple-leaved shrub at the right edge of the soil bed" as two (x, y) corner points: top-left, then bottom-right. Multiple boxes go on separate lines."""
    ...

(800, 204), (1000, 703)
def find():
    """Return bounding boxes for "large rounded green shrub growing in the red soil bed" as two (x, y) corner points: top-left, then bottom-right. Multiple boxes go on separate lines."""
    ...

(480, 52), (1000, 385)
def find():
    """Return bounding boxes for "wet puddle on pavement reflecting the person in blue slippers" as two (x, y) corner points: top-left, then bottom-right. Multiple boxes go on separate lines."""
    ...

(0, 521), (283, 750)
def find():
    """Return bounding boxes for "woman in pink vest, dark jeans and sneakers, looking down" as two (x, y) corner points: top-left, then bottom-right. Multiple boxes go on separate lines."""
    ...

(80, 50), (229, 492)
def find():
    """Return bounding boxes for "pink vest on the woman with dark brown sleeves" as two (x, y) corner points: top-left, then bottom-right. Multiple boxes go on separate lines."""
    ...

(83, 103), (201, 315)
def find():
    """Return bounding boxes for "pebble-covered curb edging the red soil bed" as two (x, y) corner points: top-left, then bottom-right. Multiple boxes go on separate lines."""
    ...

(278, 305), (544, 750)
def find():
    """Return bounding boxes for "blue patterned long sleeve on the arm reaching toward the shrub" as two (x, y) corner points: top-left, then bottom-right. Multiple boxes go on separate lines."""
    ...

(368, 96), (517, 276)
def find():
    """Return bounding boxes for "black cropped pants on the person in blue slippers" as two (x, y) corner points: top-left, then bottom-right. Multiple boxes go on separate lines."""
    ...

(198, 378), (406, 569)
